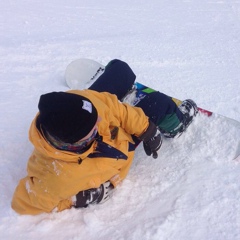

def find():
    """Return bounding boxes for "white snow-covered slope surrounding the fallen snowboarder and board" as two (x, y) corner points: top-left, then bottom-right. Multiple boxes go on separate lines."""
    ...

(0, 0), (240, 240)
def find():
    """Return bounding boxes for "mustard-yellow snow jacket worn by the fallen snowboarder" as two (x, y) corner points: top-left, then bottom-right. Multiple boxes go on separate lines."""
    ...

(12, 90), (149, 215)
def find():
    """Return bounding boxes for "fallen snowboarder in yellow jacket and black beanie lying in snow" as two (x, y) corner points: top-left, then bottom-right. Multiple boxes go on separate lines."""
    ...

(12, 60), (197, 215)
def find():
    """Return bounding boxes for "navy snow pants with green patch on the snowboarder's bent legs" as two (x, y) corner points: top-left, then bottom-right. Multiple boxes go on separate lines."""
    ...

(89, 59), (183, 137)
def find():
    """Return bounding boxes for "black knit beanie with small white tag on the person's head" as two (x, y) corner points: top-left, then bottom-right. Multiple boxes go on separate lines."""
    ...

(38, 92), (98, 143)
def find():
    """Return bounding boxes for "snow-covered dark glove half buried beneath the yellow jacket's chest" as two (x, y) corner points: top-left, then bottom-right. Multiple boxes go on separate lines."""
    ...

(74, 181), (113, 208)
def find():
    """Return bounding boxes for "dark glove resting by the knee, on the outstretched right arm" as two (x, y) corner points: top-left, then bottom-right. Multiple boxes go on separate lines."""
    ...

(139, 121), (162, 158)
